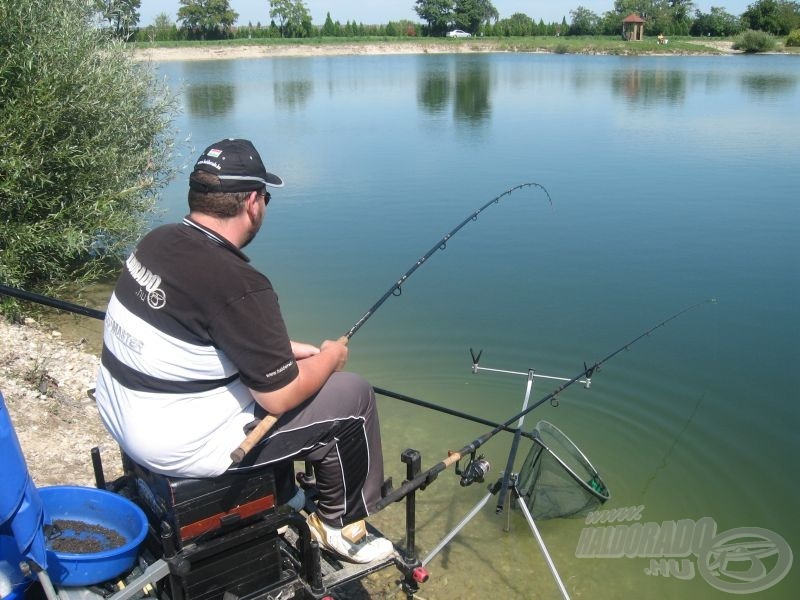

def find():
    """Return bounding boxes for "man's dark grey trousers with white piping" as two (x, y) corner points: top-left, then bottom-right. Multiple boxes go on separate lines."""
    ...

(231, 372), (383, 527)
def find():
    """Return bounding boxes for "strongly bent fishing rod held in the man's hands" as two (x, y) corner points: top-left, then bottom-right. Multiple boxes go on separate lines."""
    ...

(231, 181), (553, 465)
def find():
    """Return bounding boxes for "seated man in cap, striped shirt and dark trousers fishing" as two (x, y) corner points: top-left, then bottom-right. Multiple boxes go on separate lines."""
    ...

(96, 139), (394, 563)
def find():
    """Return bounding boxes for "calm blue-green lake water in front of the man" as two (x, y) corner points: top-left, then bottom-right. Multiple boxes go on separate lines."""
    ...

(148, 54), (800, 599)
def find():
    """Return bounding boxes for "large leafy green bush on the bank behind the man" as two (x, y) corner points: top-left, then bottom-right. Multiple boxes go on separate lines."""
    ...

(0, 0), (177, 292)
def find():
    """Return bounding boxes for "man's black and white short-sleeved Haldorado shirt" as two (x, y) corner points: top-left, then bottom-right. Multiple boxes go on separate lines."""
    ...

(96, 218), (298, 477)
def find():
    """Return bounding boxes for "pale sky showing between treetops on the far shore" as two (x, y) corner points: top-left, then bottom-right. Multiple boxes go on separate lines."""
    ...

(139, 0), (755, 25)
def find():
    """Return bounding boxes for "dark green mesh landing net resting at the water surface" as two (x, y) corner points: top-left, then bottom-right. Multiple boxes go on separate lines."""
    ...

(518, 421), (611, 519)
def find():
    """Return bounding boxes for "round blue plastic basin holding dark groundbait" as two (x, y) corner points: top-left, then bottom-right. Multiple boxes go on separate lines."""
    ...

(39, 485), (147, 586)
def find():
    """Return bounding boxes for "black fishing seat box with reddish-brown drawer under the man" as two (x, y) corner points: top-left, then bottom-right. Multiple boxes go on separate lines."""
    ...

(122, 453), (310, 600)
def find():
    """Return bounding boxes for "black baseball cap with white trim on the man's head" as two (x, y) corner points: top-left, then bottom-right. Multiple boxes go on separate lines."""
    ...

(189, 138), (283, 192)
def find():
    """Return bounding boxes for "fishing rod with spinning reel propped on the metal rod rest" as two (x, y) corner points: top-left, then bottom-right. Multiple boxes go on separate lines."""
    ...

(375, 298), (716, 510)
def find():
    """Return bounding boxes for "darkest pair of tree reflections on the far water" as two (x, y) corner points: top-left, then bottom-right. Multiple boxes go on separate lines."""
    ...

(417, 56), (491, 123)
